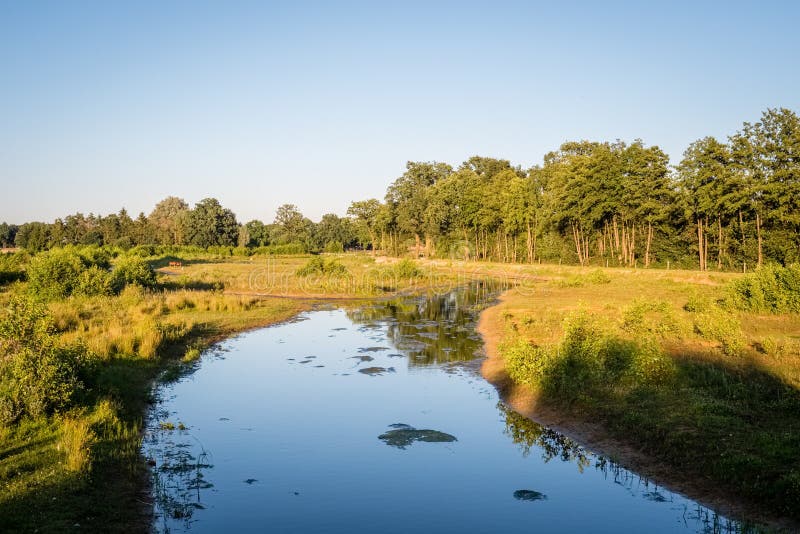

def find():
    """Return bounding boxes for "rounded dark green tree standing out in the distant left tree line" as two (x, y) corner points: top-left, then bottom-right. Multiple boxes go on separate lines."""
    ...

(184, 198), (239, 247)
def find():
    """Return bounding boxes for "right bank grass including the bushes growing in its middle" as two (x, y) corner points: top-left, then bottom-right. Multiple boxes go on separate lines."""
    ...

(484, 267), (800, 520)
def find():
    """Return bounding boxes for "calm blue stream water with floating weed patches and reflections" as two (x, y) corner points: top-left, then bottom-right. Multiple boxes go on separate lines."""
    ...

(143, 285), (739, 533)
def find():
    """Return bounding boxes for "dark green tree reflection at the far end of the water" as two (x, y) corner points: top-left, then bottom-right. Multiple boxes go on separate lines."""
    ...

(347, 281), (510, 366)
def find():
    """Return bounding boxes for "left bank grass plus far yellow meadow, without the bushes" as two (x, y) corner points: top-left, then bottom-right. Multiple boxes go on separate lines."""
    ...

(0, 255), (460, 532)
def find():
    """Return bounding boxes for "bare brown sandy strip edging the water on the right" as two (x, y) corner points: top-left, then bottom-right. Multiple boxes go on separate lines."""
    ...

(476, 290), (800, 531)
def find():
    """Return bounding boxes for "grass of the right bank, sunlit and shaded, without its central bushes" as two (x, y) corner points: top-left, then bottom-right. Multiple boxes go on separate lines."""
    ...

(468, 266), (800, 519)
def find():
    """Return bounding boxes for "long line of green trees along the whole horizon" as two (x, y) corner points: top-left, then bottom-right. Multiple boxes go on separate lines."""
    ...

(0, 108), (800, 270)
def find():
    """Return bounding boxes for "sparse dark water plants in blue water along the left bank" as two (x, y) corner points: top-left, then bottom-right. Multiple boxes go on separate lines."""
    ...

(148, 429), (213, 532)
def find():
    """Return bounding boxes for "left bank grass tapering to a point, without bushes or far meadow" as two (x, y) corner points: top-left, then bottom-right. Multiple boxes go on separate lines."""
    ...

(0, 258), (308, 532)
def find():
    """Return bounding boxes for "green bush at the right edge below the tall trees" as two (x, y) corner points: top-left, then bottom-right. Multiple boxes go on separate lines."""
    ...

(726, 264), (800, 313)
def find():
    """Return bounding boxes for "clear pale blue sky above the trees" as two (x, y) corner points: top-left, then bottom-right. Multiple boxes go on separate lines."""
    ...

(0, 0), (800, 223)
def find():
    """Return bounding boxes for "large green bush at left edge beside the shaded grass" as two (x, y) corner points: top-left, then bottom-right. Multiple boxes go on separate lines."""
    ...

(0, 298), (88, 424)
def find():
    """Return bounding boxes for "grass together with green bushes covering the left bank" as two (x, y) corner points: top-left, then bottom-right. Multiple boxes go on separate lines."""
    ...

(0, 251), (310, 532)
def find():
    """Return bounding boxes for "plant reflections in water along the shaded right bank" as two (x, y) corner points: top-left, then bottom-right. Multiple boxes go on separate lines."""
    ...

(497, 403), (744, 534)
